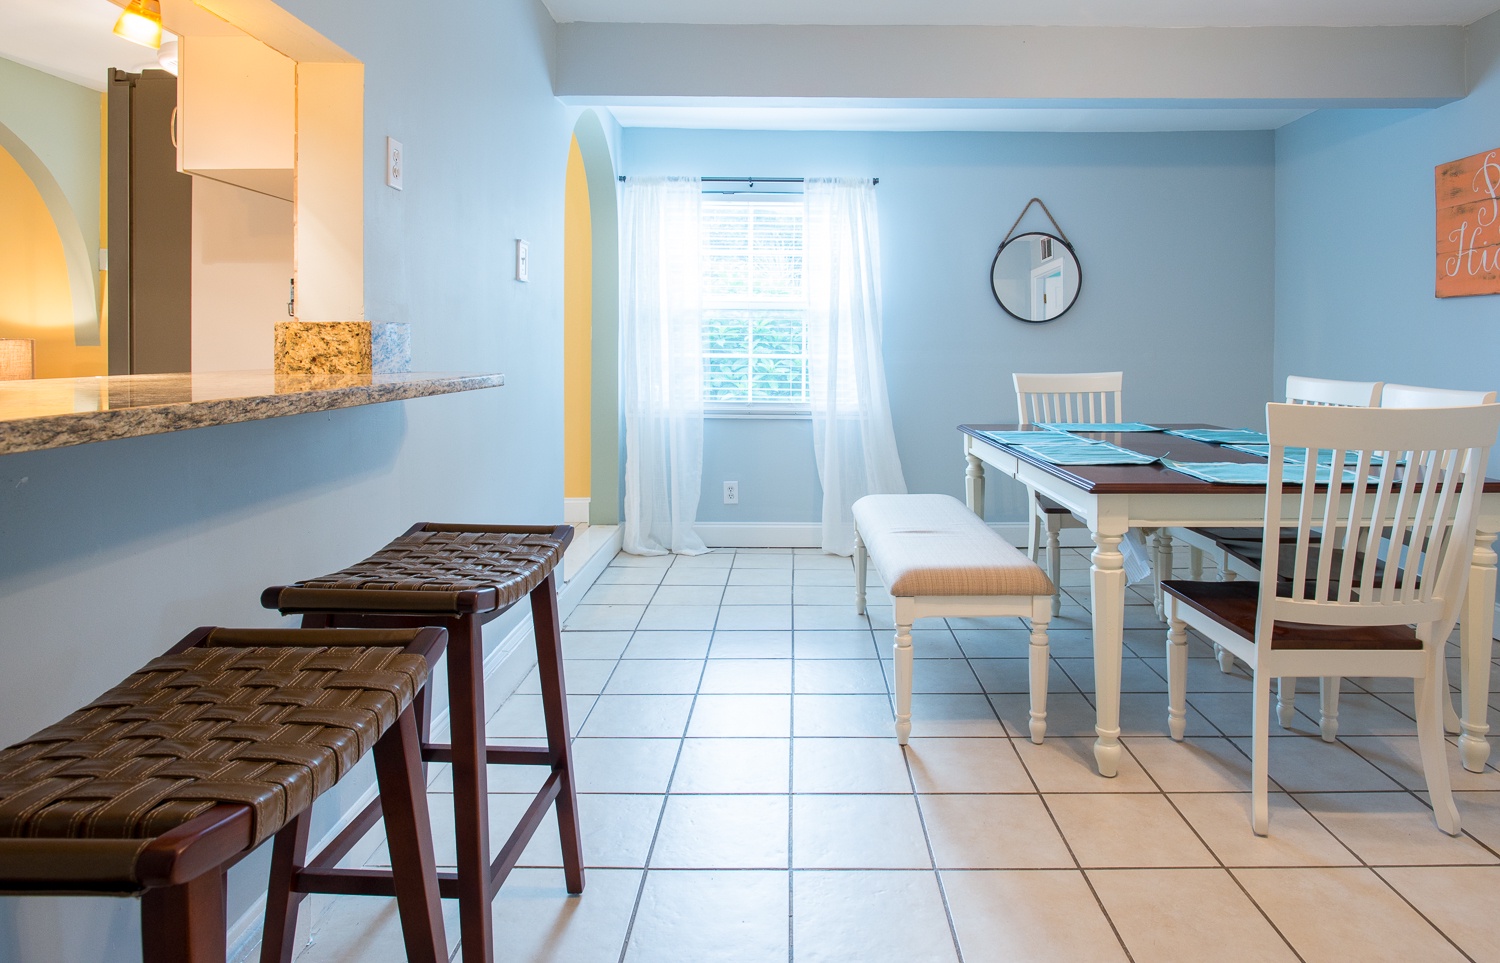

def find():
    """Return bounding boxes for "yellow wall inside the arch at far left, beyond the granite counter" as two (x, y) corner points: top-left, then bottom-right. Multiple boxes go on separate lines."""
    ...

(0, 142), (108, 378)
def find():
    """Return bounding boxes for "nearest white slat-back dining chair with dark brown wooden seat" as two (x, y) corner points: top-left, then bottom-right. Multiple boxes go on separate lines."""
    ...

(1163, 404), (1500, 836)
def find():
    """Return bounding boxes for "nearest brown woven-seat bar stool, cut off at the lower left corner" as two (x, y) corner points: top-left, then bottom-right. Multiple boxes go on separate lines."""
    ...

(0, 629), (447, 963)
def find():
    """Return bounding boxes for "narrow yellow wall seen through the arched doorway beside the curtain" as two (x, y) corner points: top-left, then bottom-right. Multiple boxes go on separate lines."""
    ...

(563, 138), (594, 498)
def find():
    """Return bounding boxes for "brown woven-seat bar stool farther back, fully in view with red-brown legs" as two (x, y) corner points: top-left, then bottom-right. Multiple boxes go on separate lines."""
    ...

(261, 522), (584, 963)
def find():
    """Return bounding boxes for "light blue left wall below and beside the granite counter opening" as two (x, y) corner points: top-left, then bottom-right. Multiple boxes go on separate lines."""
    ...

(0, 0), (576, 963)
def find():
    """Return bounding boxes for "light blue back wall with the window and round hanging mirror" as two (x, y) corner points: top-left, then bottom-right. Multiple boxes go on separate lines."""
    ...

(621, 129), (1275, 522)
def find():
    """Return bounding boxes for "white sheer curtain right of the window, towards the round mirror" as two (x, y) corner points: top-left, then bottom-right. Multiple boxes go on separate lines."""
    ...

(803, 179), (906, 555)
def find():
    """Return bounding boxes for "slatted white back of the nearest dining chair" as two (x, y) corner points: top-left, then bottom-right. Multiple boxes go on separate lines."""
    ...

(1257, 404), (1500, 642)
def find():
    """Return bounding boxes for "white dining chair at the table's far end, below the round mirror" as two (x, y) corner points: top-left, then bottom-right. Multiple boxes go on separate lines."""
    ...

(1011, 371), (1125, 615)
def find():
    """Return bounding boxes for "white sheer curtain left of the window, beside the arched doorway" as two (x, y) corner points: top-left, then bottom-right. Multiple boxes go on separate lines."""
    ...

(620, 177), (708, 555)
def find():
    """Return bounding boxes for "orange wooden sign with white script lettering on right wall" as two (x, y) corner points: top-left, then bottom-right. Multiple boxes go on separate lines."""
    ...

(1436, 149), (1500, 297)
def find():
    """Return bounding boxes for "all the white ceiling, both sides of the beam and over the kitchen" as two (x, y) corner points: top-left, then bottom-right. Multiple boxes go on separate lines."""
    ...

(0, 0), (1500, 131)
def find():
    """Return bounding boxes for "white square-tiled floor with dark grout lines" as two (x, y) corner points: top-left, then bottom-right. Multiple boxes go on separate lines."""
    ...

(289, 549), (1500, 963)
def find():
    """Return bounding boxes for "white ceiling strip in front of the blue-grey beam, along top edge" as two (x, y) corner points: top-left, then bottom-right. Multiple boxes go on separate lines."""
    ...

(542, 0), (1500, 27)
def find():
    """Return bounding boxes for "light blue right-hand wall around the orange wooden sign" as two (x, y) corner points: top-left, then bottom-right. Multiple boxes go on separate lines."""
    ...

(1275, 15), (1500, 396)
